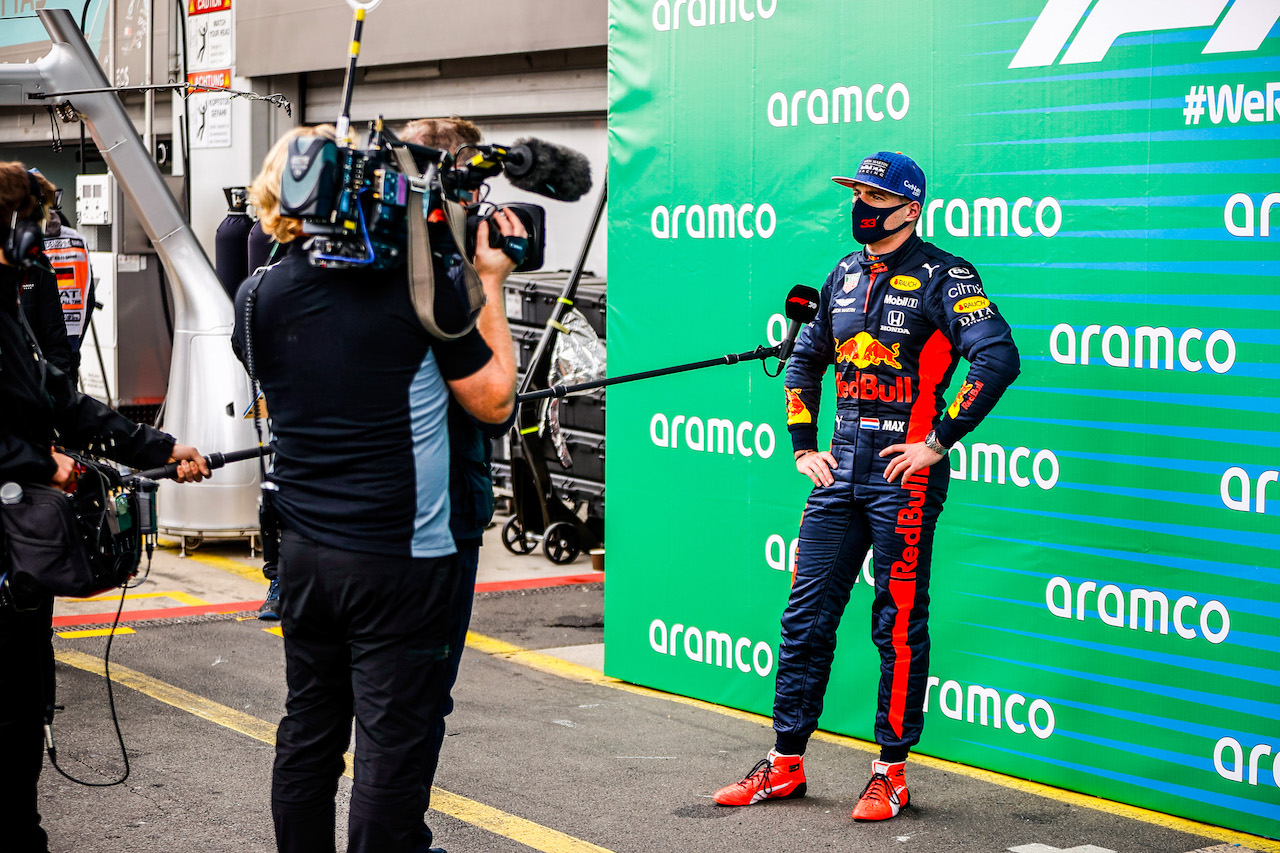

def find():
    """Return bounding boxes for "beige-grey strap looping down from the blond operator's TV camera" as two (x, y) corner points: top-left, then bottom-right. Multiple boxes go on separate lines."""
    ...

(392, 146), (485, 341)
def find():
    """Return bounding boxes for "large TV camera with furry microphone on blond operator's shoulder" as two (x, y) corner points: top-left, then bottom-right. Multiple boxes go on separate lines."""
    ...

(272, 0), (591, 338)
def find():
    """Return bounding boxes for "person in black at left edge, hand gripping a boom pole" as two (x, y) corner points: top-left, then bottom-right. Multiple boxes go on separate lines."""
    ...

(0, 163), (209, 853)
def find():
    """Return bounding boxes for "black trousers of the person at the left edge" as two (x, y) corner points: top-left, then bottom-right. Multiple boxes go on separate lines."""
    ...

(0, 597), (54, 853)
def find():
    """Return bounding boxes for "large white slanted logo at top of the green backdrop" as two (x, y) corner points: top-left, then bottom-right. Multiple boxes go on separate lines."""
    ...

(1009, 0), (1280, 68)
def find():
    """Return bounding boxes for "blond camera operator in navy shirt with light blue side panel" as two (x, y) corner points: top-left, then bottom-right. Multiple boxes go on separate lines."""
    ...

(234, 129), (524, 853)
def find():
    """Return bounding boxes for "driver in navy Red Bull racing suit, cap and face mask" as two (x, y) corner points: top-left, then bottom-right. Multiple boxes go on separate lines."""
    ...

(714, 151), (1019, 821)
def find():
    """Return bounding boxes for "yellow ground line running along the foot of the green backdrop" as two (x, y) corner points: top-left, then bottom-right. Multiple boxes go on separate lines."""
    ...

(467, 631), (1280, 853)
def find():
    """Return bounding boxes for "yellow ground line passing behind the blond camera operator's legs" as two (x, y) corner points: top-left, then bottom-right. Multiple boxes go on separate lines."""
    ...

(56, 649), (612, 853)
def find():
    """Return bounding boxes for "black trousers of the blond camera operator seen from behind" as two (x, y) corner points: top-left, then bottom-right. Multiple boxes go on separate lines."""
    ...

(271, 530), (457, 853)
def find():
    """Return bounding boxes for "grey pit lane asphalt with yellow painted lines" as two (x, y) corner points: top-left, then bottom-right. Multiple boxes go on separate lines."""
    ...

(40, 525), (1280, 853)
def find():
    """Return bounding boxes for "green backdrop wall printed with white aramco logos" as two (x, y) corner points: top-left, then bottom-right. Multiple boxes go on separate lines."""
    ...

(605, 0), (1280, 838)
